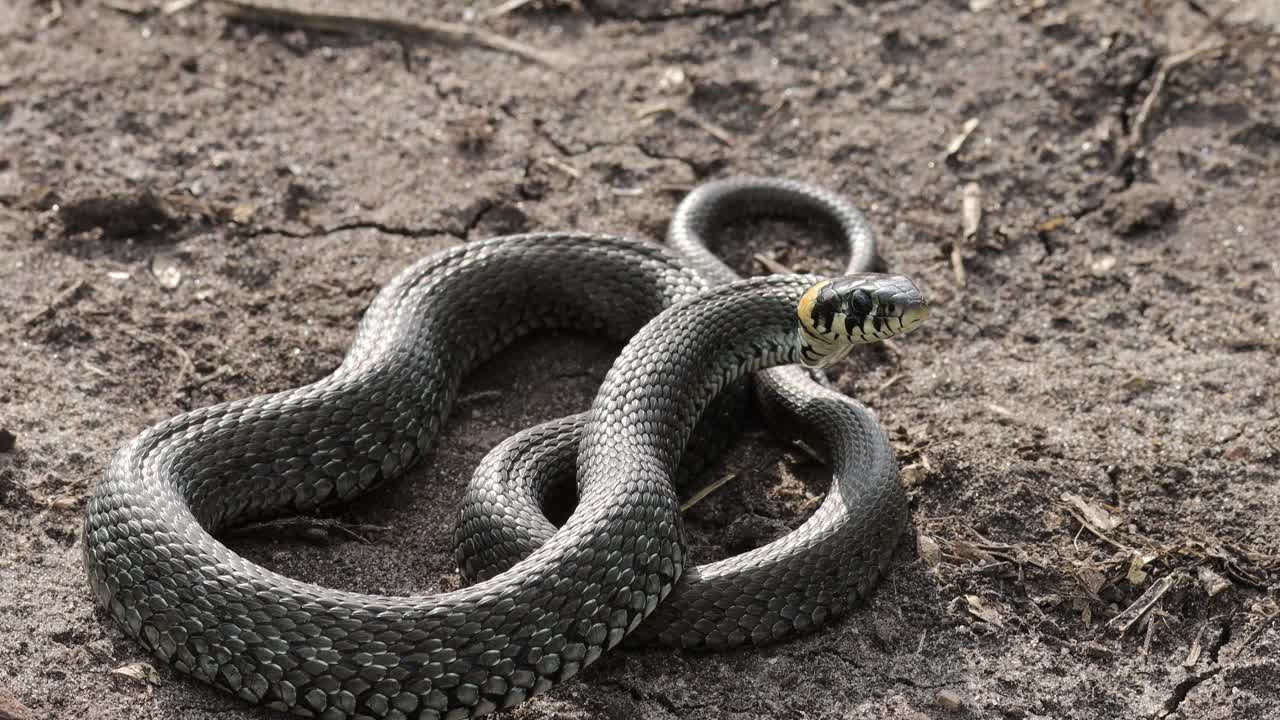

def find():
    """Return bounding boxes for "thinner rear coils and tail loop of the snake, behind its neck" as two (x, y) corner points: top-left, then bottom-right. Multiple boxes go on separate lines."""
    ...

(456, 178), (906, 650)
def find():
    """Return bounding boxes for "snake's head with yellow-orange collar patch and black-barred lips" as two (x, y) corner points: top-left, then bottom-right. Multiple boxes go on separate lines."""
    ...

(796, 273), (929, 368)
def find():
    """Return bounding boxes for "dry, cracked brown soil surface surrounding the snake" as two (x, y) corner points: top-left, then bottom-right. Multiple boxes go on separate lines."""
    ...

(0, 0), (1280, 720)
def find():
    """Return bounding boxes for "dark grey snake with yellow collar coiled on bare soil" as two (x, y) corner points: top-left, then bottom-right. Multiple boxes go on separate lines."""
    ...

(83, 178), (927, 720)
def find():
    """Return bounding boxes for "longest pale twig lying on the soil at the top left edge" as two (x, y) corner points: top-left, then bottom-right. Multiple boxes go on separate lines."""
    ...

(219, 0), (570, 69)
